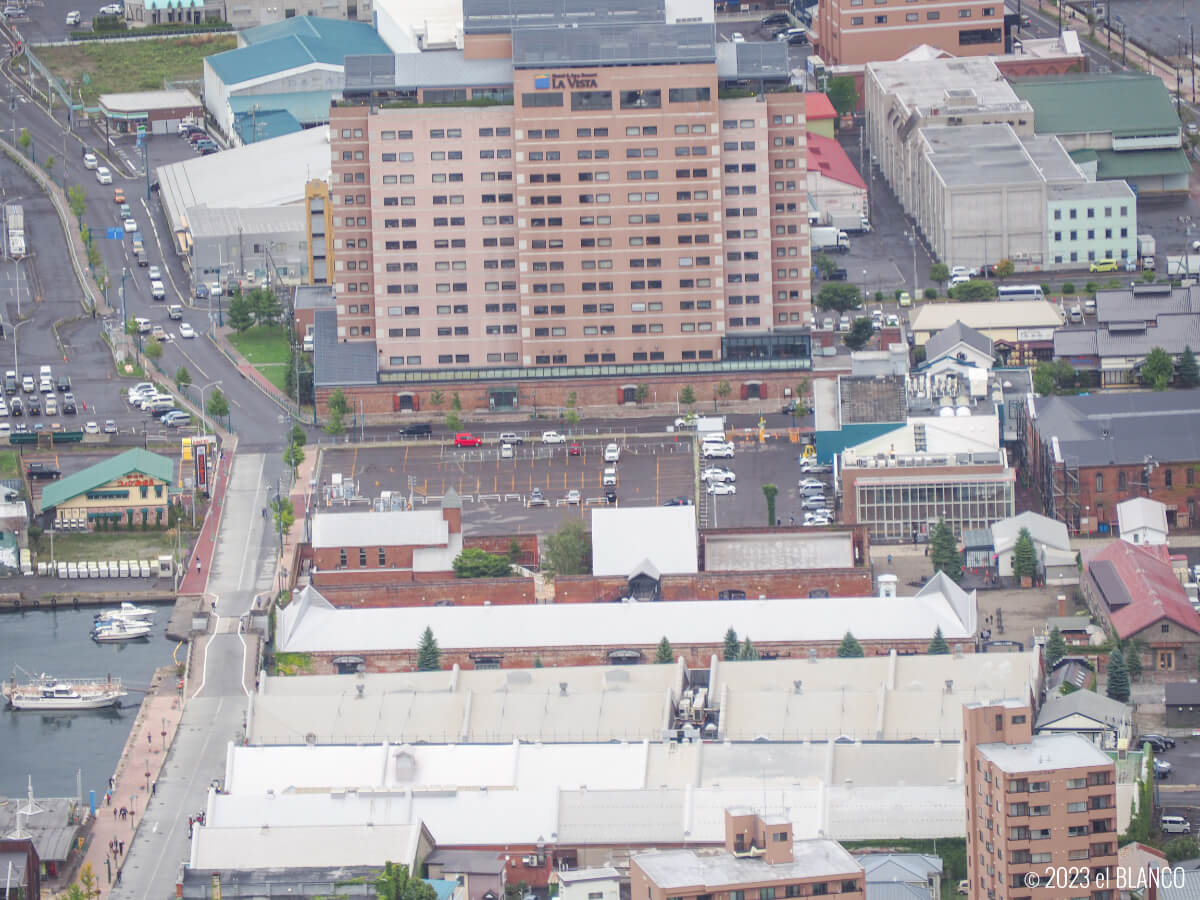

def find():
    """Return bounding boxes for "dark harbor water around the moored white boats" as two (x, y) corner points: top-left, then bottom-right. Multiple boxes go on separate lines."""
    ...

(0, 606), (171, 802)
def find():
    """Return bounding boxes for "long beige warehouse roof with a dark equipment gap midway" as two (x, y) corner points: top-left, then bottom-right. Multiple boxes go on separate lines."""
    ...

(247, 653), (1040, 745)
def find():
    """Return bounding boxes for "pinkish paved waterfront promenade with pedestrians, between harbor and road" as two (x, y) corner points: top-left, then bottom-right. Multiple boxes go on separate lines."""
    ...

(76, 670), (184, 900)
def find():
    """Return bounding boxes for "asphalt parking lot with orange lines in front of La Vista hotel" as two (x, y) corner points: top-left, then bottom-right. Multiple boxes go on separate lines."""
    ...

(320, 430), (833, 534)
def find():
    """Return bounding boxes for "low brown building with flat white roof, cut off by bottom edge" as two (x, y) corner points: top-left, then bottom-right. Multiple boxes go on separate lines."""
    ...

(629, 808), (866, 900)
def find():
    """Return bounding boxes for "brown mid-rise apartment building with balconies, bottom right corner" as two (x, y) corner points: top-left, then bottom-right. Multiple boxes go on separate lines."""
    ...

(962, 700), (1117, 900)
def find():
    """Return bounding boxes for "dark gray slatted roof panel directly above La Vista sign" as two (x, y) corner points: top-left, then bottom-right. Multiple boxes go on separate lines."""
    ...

(512, 23), (716, 68)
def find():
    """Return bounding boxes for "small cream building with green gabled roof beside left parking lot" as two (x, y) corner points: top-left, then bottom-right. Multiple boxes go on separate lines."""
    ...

(38, 449), (175, 530)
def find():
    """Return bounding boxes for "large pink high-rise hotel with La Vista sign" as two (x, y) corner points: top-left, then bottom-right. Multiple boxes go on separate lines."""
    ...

(314, 19), (811, 409)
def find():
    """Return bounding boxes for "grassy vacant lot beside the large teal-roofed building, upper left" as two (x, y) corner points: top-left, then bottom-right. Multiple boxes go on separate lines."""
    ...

(35, 35), (238, 106)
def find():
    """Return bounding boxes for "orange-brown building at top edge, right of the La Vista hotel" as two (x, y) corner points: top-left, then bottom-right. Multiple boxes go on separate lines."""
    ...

(812, 0), (1004, 65)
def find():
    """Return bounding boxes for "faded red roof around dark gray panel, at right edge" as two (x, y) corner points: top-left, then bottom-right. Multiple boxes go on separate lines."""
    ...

(1087, 540), (1200, 638)
